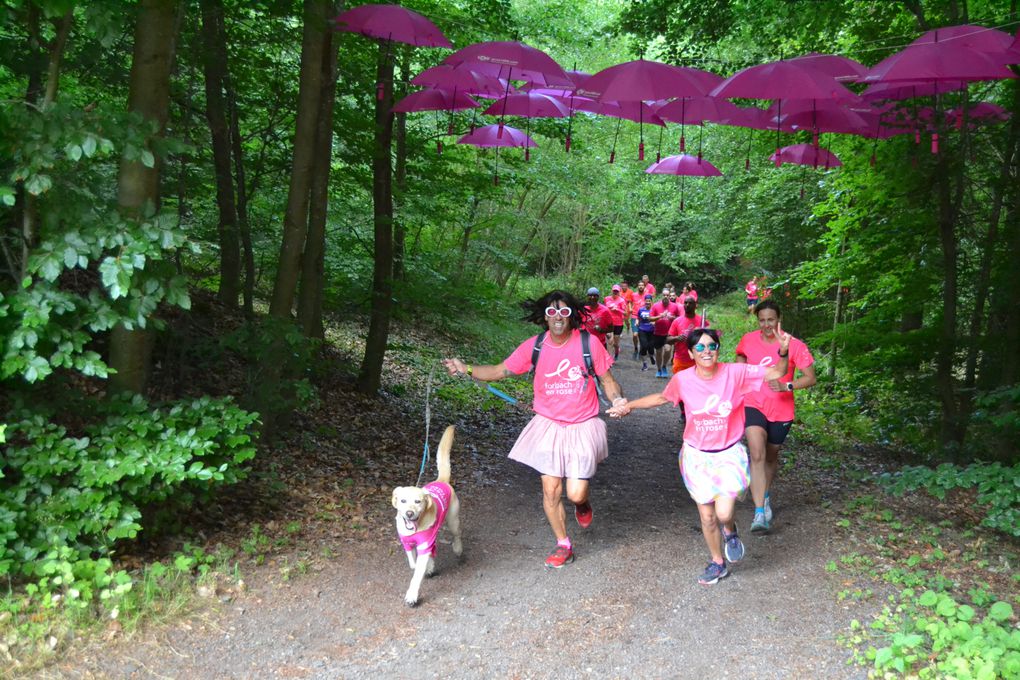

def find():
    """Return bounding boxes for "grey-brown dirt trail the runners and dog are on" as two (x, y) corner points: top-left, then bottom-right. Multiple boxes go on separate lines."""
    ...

(55, 354), (866, 678)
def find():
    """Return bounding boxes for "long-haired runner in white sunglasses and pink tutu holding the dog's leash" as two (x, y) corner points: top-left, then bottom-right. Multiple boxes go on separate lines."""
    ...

(443, 291), (626, 569)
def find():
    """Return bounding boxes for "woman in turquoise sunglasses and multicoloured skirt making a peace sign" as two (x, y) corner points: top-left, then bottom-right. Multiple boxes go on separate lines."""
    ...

(608, 328), (789, 585)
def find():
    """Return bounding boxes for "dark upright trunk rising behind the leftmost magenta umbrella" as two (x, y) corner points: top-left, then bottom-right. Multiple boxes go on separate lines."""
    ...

(358, 41), (393, 395)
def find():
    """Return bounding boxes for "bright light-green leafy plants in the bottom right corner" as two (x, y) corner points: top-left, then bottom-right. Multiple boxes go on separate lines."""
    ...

(855, 589), (1020, 680)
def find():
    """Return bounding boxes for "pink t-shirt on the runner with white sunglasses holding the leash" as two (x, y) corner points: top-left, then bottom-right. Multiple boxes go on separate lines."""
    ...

(503, 330), (613, 424)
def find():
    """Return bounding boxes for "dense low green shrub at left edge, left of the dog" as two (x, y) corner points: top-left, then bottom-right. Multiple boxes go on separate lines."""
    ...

(0, 397), (257, 607)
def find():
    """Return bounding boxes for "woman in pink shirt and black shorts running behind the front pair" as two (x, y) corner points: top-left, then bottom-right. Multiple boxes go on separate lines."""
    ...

(736, 300), (815, 533)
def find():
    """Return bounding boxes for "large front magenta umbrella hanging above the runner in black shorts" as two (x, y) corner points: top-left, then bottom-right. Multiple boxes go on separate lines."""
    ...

(711, 61), (858, 167)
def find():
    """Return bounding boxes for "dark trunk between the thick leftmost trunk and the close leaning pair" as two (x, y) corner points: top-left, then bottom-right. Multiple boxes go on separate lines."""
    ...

(202, 0), (241, 307)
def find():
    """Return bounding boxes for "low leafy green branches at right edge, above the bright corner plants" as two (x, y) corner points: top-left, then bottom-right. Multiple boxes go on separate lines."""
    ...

(880, 463), (1020, 537)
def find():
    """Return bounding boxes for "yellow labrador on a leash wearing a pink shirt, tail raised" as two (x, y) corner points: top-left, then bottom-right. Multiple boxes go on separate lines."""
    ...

(393, 425), (464, 607)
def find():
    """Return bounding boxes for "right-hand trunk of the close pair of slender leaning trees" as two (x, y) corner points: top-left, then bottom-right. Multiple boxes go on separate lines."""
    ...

(298, 6), (340, 338)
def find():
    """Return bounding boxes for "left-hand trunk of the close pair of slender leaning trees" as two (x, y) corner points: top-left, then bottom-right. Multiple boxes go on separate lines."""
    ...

(269, 0), (329, 319)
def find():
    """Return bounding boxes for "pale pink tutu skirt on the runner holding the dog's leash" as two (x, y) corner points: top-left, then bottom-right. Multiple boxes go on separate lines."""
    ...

(510, 415), (609, 479)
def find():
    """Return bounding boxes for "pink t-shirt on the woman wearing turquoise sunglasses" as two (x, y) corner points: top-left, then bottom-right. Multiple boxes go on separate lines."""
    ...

(662, 364), (765, 451)
